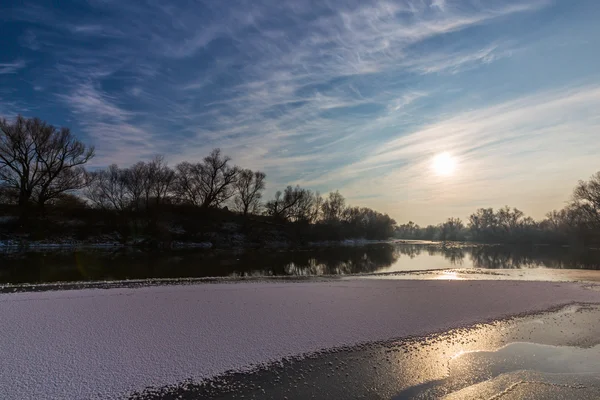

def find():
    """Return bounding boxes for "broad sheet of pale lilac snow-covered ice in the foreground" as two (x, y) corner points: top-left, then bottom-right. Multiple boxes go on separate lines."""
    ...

(0, 280), (600, 399)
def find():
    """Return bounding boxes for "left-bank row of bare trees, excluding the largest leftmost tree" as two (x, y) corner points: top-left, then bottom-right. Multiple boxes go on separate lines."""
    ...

(83, 149), (396, 238)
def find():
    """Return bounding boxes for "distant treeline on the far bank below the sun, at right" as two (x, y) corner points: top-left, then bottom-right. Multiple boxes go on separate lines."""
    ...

(396, 172), (600, 245)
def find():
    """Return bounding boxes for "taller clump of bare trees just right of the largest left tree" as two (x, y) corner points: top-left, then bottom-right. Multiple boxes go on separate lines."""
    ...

(83, 149), (266, 215)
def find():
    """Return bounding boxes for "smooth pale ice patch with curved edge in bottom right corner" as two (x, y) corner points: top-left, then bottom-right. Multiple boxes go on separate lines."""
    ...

(393, 342), (600, 400)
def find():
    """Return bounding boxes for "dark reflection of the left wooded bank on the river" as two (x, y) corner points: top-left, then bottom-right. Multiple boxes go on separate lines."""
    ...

(0, 245), (398, 283)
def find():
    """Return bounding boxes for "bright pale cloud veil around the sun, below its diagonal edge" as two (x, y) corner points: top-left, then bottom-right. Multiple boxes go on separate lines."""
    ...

(320, 85), (600, 223)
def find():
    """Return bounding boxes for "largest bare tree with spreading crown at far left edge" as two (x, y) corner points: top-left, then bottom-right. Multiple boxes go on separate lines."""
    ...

(0, 116), (94, 214)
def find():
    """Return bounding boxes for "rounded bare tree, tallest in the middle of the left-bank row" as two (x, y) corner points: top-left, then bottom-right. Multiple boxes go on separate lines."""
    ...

(176, 149), (239, 208)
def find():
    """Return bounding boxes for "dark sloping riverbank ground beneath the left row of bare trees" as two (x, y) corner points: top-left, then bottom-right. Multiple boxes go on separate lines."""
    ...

(0, 204), (394, 249)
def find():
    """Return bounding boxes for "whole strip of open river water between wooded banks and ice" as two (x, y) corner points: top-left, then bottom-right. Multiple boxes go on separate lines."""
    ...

(0, 244), (600, 283)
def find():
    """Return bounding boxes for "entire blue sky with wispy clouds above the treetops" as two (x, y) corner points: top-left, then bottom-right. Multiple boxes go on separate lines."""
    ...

(0, 0), (600, 225)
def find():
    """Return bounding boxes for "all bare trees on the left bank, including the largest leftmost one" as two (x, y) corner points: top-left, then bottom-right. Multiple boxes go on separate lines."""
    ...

(0, 116), (396, 240)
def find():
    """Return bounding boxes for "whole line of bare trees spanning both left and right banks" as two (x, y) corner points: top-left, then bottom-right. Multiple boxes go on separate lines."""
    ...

(7, 116), (600, 245)
